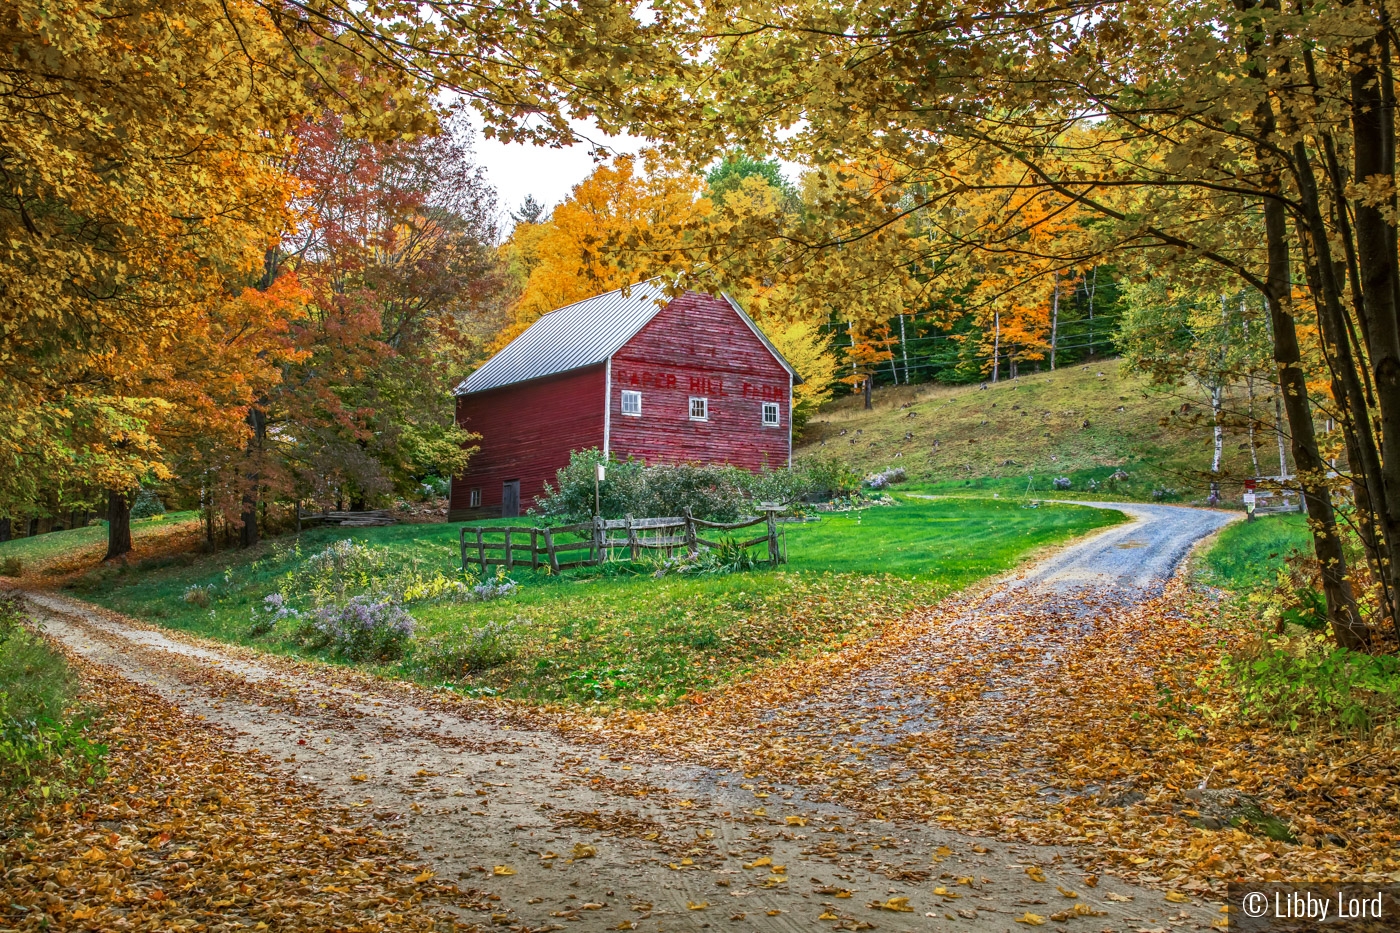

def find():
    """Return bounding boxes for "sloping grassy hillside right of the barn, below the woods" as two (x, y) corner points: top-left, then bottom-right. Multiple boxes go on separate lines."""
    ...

(794, 360), (1278, 503)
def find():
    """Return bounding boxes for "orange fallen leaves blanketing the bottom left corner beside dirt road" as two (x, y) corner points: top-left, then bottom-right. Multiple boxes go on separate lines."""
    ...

(0, 657), (486, 933)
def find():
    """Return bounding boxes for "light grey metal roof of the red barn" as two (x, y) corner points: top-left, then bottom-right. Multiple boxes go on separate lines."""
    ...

(456, 279), (801, 395)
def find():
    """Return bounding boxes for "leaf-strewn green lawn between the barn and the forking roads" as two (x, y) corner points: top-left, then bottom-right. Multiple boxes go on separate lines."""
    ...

(54, 499), (1121, 706)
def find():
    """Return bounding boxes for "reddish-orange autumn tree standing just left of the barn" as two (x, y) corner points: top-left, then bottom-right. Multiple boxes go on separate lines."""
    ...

(225, 115), (500, 537)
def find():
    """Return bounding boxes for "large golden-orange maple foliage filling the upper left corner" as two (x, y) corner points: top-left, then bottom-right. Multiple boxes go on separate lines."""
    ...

(0, 0), (445, 556)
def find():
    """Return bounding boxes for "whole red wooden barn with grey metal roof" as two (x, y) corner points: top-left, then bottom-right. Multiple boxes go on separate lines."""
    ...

(448, 282), (801, 521)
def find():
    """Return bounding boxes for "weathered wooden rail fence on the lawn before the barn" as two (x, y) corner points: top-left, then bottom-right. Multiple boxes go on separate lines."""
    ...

(459, 506), (787, 573)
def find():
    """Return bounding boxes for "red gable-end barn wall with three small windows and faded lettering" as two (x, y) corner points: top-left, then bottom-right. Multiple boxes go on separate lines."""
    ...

(608, 291), (792, 469)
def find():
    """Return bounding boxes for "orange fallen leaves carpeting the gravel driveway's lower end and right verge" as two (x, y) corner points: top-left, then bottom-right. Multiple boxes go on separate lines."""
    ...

(549, 579), (1400, 885)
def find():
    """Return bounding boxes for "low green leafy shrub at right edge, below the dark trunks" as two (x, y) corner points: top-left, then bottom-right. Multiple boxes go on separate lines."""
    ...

(1221, 632), (1400, 733)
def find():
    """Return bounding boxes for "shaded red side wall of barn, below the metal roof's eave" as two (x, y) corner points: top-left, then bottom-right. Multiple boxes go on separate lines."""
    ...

(448, 364), (606, 521)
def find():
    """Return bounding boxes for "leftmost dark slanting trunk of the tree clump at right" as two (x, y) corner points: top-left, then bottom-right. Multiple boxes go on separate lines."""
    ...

(1261, 187), (1371, 650)
